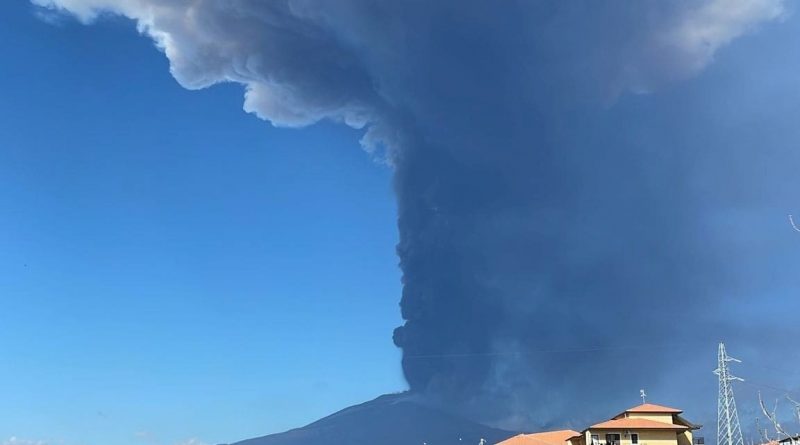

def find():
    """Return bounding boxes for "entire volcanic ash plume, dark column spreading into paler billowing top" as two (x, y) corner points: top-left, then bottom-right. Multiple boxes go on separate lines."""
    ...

(34, 0), (798, 427)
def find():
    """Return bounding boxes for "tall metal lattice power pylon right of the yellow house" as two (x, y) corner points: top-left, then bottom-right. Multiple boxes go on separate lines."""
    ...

(714, 343), (744, 445)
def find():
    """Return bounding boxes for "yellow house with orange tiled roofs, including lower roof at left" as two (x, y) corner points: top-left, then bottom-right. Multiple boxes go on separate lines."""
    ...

(497, 403), (700, 445)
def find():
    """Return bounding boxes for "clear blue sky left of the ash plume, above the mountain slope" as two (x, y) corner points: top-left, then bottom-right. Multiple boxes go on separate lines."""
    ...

(0, 1), (405, 445)
